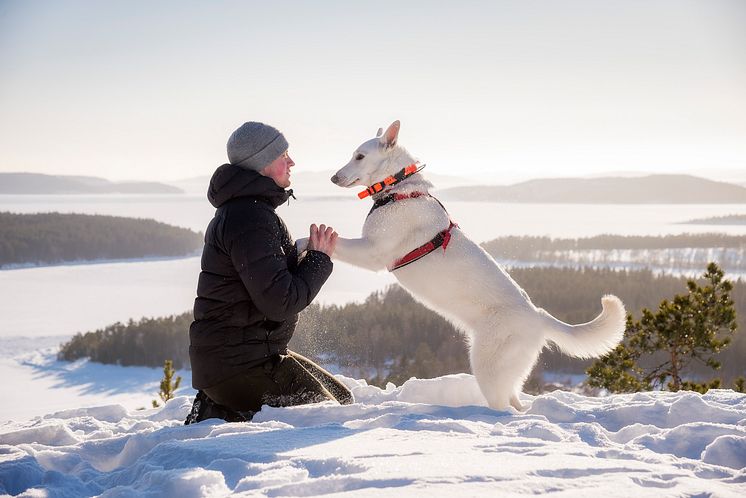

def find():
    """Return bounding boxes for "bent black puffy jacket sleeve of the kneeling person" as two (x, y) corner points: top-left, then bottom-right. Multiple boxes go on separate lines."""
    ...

(230, 226), (334, 321)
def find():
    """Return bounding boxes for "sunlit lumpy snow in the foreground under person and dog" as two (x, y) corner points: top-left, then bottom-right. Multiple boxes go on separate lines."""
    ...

(0, 374), (746, 498)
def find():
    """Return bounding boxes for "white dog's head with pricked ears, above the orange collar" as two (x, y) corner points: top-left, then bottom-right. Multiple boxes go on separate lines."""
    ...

(331, 121), (414, 187)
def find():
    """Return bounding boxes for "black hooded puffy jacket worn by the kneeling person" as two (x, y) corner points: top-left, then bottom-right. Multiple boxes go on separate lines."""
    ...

(189, 164), (332, 389)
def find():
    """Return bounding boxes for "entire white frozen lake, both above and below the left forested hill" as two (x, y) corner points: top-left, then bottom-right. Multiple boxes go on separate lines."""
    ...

(0, 191), (746, 337)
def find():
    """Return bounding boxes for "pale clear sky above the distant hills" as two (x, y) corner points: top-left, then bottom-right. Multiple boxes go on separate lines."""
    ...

(0, 0), (746, 181)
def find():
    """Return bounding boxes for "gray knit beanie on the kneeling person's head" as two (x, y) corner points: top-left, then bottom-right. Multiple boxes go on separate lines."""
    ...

(228, 121), (288, 171)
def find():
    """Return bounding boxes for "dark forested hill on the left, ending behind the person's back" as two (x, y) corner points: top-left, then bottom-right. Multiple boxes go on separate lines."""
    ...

(0, 212), (203, 268)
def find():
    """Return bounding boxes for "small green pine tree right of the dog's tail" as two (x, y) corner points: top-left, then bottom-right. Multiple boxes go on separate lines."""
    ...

(587, 263), (736, 392)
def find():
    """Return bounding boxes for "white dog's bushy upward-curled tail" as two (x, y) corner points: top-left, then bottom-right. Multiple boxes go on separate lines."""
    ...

(541, 295), (627, 358)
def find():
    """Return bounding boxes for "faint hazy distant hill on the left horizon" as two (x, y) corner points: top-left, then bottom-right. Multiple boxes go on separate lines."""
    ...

(0, 173), (184, 195)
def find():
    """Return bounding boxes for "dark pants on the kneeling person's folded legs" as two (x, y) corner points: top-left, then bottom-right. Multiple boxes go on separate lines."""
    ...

(186, 351), (353, 424)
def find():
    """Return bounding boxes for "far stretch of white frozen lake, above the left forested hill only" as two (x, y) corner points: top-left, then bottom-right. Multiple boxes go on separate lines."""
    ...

(0, 190), (746, 238)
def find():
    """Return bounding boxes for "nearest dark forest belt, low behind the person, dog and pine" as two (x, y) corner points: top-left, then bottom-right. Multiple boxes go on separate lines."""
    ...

(59, 268), (746, 386)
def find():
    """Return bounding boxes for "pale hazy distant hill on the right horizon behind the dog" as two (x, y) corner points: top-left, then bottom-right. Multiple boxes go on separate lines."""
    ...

(438, 175), (746, 204)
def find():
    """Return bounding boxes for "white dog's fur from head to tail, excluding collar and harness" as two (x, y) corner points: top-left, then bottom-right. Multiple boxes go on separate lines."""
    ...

(300, 121), (625, 410)
